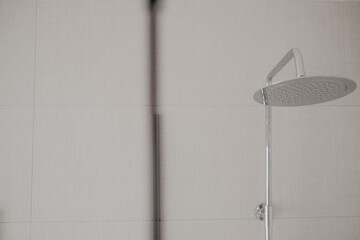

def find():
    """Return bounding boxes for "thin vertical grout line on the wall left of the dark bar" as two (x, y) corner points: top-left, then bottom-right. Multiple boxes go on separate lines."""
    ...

(29, 0), (38, 240)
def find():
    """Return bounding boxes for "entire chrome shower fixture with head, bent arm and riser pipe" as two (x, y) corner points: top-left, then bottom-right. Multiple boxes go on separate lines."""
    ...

(254, 48), (356, 240)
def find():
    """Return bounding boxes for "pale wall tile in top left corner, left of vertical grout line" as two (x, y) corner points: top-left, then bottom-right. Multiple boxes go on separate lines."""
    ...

(0, 0), (36, 105)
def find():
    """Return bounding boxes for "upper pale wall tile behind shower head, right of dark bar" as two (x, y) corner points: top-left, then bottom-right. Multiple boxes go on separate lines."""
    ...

(160, 0), (360, 105)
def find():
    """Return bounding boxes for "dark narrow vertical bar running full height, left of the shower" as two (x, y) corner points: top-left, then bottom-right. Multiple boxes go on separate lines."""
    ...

(149, 0), (161, 240)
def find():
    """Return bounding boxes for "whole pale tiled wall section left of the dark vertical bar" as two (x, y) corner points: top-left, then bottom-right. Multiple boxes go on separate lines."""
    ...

(0, 0), (153, 237)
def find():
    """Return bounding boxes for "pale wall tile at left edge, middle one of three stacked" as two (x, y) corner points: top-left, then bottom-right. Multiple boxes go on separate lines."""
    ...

(0, 107), (33, 222)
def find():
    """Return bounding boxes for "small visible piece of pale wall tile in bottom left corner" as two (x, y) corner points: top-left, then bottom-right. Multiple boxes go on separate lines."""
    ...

(0, 223), (30, 240)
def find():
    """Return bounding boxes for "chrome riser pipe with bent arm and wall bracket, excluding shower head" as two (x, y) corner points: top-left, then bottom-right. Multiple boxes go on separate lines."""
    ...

(256, 48), (305, 240)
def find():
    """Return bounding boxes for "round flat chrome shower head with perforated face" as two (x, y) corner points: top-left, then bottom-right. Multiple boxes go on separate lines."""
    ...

(254, 76), (356, 107)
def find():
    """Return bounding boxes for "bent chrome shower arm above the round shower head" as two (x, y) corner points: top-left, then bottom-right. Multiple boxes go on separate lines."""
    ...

(266, 48), (305, 84)
